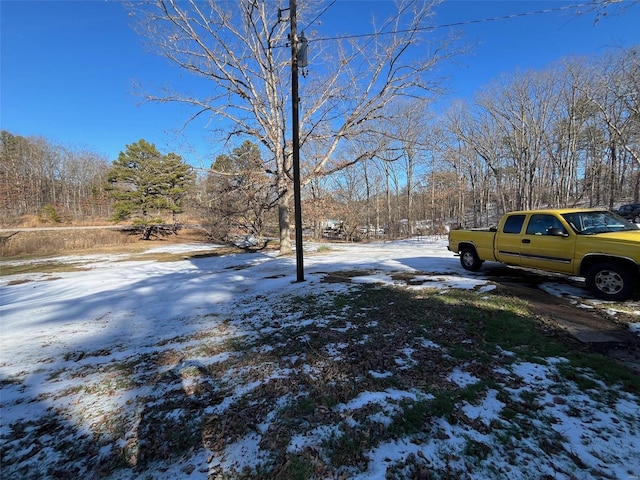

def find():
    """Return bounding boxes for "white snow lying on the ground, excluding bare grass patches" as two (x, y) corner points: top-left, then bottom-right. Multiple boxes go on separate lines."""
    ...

(0, 238), (640, 479)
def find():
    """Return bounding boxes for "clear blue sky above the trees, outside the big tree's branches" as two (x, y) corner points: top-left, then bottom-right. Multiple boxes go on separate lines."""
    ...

(0, 0), (640, 166)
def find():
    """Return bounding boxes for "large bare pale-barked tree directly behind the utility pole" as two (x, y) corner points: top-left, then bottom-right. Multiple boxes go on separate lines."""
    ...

(132, 0), (451, 253)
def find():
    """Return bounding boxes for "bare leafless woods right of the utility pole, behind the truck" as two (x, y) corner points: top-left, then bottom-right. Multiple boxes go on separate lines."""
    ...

(294, 47), (640, 236)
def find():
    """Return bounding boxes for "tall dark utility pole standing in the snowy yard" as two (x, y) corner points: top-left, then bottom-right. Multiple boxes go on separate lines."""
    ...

(289, 0), (304, 282)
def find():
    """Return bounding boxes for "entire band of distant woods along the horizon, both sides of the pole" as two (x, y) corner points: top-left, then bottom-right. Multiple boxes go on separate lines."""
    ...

(0, 48), (640, 235)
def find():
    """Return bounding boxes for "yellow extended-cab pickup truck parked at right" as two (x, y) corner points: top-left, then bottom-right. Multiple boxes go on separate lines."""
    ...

(447, 208), (640, 300)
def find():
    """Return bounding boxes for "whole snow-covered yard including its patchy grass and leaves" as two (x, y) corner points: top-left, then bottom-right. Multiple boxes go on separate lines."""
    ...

(0, 238), (640, 479)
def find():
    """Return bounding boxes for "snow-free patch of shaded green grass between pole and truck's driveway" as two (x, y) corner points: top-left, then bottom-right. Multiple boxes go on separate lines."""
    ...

(288, 284), (640, 400)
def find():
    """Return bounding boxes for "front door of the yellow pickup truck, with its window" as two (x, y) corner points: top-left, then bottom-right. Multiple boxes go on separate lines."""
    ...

(520, 213), (574, 273)
